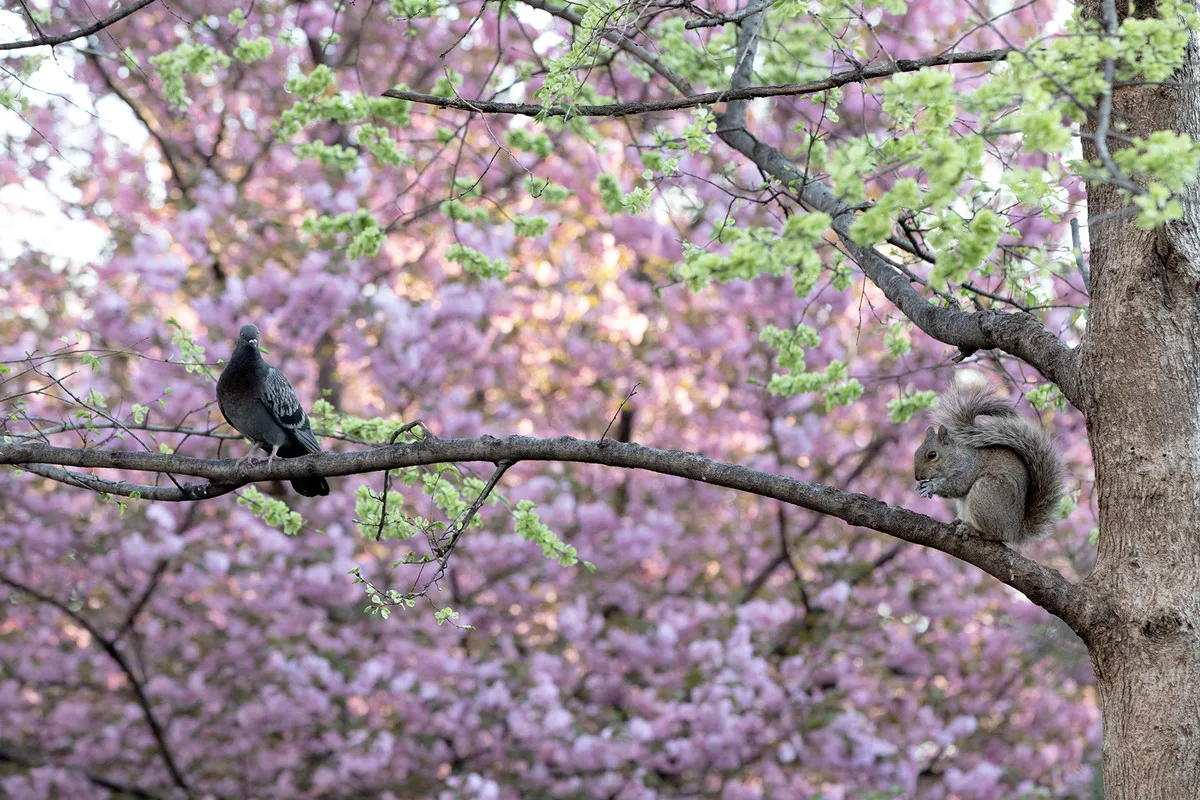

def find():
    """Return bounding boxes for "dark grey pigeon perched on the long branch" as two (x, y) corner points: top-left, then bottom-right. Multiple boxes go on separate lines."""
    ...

(217, 325), (329, 498)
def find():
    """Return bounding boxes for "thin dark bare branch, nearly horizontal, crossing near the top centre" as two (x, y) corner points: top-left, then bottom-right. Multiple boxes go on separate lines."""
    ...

(383, 48), (1013, 116)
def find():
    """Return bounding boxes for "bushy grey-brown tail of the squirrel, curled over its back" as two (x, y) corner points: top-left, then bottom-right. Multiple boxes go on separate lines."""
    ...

(934, 387), (1067, 540)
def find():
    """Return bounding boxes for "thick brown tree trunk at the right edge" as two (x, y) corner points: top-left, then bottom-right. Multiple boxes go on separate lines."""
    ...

(1080, 17), (1200, 800)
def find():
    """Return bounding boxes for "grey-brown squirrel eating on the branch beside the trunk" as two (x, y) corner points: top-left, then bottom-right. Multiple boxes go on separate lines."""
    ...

(912, 387), (1066, 545)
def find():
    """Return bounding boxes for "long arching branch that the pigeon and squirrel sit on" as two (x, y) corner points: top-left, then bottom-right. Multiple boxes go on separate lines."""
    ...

(0, 437), (1103, 638)
